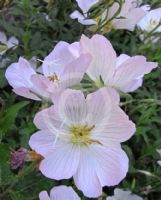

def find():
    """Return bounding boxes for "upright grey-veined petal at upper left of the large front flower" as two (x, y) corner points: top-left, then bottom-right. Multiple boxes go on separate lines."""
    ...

(58, 89), (87, 125)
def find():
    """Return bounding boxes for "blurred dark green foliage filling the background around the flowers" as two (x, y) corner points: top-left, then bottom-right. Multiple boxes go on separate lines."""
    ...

(0, 0), (161, 200)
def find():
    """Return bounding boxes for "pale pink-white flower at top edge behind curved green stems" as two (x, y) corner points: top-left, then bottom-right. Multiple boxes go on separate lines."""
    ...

(70, 0), (146, 31)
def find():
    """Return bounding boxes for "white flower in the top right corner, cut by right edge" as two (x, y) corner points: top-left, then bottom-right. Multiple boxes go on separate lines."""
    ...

(137, 8), (161, 33)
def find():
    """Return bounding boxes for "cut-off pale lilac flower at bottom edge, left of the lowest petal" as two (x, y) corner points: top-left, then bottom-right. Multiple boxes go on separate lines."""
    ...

(39, 185), (80, 200)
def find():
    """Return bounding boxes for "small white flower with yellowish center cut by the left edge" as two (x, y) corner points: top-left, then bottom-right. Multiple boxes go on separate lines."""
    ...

(0, 32), (19, 55)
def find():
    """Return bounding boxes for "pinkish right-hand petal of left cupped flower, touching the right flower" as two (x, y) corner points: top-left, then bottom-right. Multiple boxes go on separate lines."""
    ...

(60, 54), (91, 88)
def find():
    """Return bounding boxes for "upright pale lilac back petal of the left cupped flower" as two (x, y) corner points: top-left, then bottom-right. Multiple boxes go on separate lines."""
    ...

(42, 41), (73, 77)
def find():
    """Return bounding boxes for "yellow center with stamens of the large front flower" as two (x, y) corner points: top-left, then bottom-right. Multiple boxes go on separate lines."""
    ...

(70, 124), (101, 145)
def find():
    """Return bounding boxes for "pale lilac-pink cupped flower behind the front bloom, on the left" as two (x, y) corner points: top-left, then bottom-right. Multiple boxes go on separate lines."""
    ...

(6, 42), (90, 101)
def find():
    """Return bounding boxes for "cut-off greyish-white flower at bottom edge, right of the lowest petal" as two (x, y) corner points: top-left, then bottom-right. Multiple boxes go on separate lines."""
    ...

(106, 188), (143, 200)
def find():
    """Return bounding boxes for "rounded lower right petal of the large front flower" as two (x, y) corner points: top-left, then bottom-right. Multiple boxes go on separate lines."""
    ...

(91, 145), (129, 186)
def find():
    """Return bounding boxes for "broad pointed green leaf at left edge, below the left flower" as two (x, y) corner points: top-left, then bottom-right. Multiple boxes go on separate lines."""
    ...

(0, 101), (29, 138)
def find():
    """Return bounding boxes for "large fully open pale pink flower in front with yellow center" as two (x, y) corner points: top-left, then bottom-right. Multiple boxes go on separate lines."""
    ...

(29, 88), (135, 197)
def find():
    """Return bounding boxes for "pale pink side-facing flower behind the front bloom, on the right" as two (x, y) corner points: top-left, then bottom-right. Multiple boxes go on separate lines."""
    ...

(80, 35), (157, 92)
